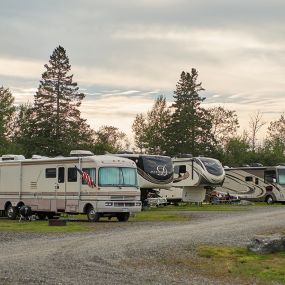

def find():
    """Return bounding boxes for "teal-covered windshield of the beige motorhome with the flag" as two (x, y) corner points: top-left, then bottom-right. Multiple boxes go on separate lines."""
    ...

(99, 167), (138, 187)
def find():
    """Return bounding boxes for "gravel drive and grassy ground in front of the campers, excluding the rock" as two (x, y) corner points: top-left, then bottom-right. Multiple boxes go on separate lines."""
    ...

(0, 203), (285, 284)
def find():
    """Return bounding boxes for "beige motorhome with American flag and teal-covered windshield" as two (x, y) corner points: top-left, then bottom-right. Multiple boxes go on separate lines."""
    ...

(0, 155), (141, 221)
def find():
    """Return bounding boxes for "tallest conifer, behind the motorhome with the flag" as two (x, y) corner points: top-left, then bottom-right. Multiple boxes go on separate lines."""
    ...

(32, 46), (91, 155)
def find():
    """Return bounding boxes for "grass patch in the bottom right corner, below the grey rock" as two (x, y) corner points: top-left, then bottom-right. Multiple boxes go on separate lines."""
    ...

(198, 246), (285, 284)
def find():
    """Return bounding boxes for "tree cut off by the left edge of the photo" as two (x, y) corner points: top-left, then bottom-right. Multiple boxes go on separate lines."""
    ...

(0, 86), (16, 154)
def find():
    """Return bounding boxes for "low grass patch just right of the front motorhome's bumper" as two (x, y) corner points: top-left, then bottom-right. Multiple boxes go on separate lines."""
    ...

(130, 209), (190, 222)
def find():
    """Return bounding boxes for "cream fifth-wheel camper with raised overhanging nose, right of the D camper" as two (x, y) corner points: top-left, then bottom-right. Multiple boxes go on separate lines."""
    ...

(160, 157), (225, 202)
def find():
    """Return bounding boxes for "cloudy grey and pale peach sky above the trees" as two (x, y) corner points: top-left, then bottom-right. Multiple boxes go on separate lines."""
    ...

(0, 0), (285, 141)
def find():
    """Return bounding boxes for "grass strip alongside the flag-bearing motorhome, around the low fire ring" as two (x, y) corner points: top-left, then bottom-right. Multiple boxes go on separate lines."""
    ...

(0, 220), (89, 233)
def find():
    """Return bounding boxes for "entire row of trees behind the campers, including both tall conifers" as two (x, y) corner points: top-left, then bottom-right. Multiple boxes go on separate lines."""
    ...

(0, 46), (285, 166)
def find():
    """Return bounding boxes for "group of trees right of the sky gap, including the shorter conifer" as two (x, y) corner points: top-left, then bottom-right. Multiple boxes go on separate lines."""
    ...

(132, 68), (285, 167)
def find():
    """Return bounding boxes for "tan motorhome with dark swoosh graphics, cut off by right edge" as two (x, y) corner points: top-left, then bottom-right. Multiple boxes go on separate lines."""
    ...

(216, 166), (285, 204)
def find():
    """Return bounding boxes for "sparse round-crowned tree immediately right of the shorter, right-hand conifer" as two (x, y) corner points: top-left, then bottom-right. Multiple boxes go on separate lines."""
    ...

(208, 106), (239, 147)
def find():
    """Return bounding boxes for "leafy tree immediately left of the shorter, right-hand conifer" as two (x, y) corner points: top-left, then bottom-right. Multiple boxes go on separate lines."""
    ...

(132, 95), (170, 154)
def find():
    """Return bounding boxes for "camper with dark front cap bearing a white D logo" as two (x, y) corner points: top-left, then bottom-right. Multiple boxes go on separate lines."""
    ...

(113, 153), (173, 201)
